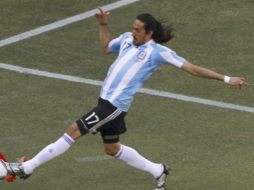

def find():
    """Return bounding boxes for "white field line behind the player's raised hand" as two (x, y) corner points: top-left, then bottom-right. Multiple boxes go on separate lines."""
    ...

(0, 0), (139, 47)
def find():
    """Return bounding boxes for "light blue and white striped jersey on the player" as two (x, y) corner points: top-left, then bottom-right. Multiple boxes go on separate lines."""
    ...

(100, 32), (186, 112)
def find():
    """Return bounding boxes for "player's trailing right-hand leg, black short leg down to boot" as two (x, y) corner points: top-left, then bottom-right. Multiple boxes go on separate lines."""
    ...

(100, 119), (169, 190)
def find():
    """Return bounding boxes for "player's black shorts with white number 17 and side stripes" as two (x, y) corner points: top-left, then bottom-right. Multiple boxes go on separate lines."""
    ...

(76, 98), (126, 143)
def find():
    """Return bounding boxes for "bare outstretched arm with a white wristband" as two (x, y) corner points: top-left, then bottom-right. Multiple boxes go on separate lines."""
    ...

(181, 62), (246, 88)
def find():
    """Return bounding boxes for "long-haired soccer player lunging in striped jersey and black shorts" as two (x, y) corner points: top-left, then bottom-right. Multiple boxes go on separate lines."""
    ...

(2, 8), (245, 190)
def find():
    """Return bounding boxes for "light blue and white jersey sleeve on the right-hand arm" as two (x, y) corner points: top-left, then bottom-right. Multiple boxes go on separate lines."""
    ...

(156, 47), (186, 68)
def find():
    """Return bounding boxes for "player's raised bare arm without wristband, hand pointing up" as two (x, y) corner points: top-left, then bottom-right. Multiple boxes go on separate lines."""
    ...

(95, 7), (111, 54)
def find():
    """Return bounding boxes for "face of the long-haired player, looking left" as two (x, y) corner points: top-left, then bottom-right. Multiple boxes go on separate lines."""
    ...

(132, 20), (152, 46)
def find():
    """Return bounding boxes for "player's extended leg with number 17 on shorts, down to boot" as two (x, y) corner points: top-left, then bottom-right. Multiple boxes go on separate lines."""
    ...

(4, 99), (121, 178)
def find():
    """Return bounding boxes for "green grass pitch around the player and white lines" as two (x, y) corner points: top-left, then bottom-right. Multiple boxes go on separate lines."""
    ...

(0, 0), (254, 190)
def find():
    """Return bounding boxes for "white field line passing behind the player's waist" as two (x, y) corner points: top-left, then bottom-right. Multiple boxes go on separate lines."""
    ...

(0, 63), (254, 113)
